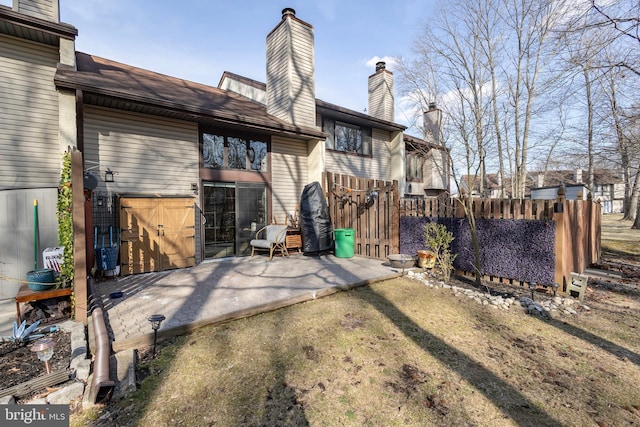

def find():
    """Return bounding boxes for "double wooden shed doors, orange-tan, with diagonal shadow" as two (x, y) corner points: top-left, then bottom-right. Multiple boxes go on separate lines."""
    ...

(120, 197), (195, 274)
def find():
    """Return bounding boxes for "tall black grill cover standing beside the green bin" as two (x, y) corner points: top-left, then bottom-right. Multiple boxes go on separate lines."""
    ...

(300, 182), (333, 254)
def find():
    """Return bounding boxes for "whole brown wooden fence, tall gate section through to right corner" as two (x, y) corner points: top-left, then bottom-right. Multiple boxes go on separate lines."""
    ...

(322, 172), (602, 293)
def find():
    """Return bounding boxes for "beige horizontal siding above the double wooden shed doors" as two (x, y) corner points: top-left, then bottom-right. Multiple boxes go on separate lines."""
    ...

(84, 107), (198, 195)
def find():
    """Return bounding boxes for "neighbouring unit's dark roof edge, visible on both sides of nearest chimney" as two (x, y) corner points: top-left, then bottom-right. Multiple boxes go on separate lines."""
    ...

(218, 71), (407, 132)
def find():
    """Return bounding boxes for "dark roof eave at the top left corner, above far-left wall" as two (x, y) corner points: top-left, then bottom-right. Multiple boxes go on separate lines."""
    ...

(0, 5), (78, 46)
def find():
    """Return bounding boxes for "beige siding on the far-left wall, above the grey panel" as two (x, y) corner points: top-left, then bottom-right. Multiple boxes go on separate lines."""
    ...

(0, 34), (61, 189)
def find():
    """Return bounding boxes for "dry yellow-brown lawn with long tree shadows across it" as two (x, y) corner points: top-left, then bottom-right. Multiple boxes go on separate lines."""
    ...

(72, 217), (640, 427)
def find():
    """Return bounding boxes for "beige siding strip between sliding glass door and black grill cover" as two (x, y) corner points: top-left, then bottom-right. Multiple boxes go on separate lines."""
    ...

(271, 137), (309, 222)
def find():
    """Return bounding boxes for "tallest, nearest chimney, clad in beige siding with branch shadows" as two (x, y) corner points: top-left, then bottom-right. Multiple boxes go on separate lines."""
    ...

(267, 8), (316, 127)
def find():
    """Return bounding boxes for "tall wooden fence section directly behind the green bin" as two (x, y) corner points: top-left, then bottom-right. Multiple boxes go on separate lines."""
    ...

(322, 172), (400, 259)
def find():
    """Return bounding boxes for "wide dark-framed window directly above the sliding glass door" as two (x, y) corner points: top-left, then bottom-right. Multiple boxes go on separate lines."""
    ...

(202, 133), (268, 172)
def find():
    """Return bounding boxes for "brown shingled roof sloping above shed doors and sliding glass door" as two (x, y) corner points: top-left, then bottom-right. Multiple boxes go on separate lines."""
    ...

(54, 52), (326, 139)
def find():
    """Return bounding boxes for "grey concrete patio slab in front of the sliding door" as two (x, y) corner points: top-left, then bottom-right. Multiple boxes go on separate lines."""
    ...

(95, 254), (401, 352)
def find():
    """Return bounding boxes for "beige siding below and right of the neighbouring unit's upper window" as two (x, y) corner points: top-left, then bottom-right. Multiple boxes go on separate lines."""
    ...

(326, 129), (391, 181)
